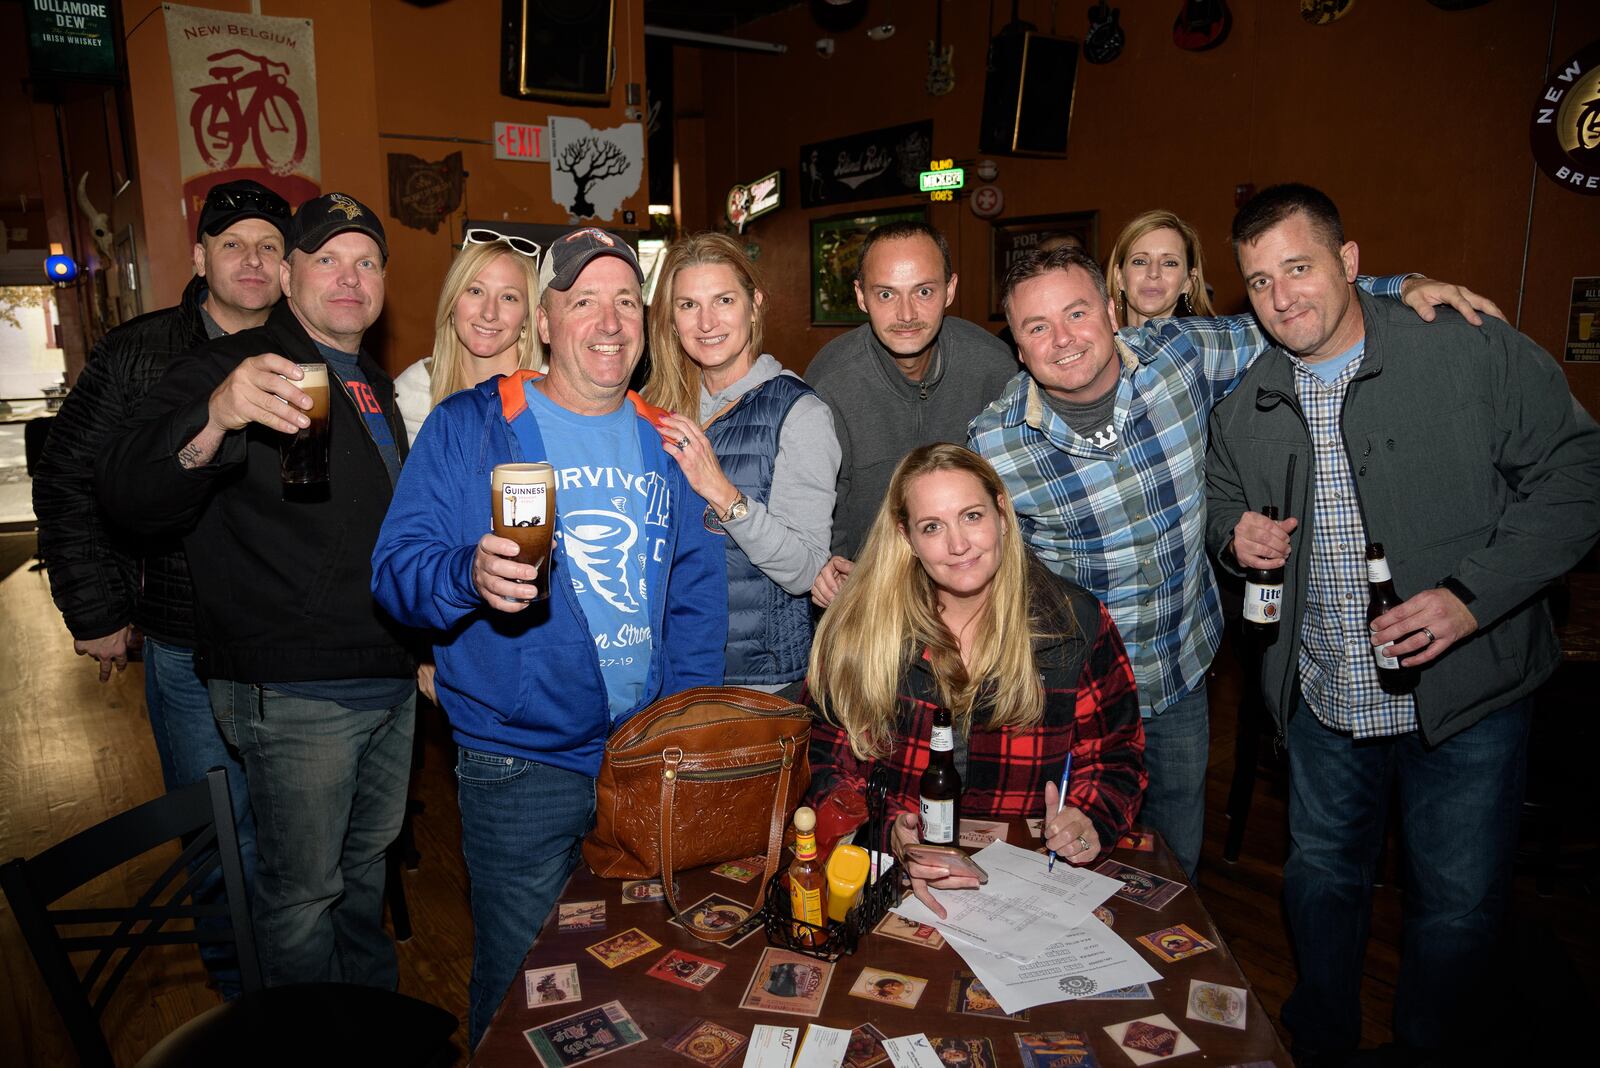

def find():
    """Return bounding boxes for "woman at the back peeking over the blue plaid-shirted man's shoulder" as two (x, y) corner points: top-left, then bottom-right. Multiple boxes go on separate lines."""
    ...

(1106, 209), (1216, 326)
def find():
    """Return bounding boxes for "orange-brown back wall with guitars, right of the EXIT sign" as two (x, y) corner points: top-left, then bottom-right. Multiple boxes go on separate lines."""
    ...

(678, 0), (1600, 412)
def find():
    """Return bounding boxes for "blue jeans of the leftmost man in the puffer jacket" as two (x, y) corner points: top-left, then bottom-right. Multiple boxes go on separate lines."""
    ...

(144, 638), (256, 998)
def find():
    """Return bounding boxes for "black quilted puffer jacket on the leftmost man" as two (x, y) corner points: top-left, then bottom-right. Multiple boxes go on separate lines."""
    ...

(34, 277), (206, 646)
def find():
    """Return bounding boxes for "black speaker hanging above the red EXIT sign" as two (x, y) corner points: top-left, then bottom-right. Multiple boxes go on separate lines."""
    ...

(501, 0), (616, 107)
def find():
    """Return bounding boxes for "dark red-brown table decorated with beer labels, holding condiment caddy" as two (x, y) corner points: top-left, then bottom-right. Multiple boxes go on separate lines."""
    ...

(472, 822), (1293, 1068)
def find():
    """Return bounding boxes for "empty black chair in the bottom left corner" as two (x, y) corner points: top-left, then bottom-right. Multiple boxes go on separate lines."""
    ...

(0, 767), (456, 1068)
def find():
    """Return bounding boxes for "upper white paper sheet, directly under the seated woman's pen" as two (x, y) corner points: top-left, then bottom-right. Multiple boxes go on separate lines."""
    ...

(893, 841), (1122, 964)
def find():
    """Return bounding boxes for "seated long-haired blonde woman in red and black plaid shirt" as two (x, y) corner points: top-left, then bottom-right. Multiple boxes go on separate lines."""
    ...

(806, 443), (1146, 916)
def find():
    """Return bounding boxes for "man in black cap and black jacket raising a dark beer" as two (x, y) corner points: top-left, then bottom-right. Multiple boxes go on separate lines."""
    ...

(98, 193), (416, 990)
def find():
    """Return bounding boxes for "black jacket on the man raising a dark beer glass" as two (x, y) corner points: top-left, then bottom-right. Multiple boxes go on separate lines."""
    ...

(96, 299), (413, 683)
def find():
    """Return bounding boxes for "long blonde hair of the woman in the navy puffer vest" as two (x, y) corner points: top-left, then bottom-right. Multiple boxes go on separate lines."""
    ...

(640, 232), (766, 422)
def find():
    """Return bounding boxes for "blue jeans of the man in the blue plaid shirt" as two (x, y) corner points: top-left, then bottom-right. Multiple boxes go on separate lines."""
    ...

(1139, 679), (1211, 883)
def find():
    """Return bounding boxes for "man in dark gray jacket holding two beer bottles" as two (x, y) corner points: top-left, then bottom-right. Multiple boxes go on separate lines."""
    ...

(1206, 185), (1600, 1065)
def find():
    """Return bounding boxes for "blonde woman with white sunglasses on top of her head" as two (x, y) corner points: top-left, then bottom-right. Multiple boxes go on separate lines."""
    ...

(395, 229), (544, 441)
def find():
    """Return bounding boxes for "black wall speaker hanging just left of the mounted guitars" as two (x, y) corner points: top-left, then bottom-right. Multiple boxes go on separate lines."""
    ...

(978, 22), (1078, 157)
